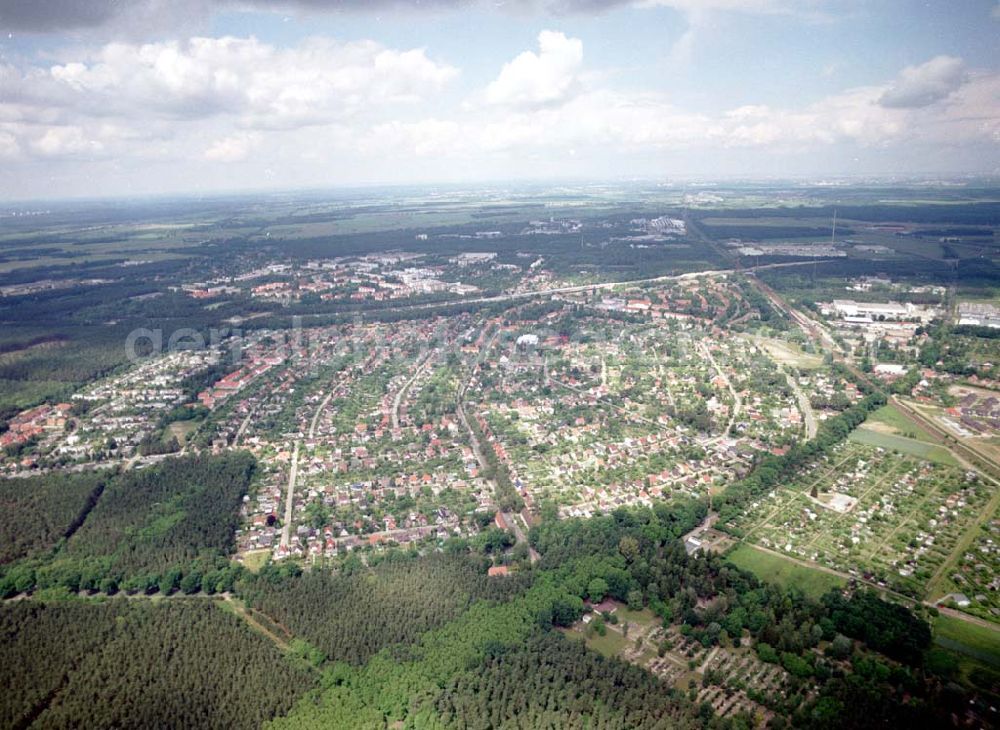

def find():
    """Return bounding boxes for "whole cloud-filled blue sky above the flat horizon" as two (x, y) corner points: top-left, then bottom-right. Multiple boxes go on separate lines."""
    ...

(0, 0), (1000, 198)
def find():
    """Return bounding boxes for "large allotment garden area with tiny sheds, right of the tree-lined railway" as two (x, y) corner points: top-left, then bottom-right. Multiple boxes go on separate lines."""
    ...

(734, 442), (989, 597)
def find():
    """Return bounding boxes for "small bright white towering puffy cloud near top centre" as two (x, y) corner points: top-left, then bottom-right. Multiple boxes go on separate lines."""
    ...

(485, 30), (583, 107)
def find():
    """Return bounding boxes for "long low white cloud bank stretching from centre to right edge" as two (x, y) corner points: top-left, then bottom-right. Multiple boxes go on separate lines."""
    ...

(372, 60), (1000, 160)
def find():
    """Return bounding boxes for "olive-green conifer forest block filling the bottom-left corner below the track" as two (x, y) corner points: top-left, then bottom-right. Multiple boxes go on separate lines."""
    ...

(0, 599), (317, 728)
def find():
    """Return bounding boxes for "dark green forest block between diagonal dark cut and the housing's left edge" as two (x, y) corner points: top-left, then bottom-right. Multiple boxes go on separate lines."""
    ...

(0, 452), (255, 596)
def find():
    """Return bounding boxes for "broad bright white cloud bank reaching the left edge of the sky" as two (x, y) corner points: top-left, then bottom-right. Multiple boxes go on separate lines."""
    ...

(0, 37), (458, 160)
